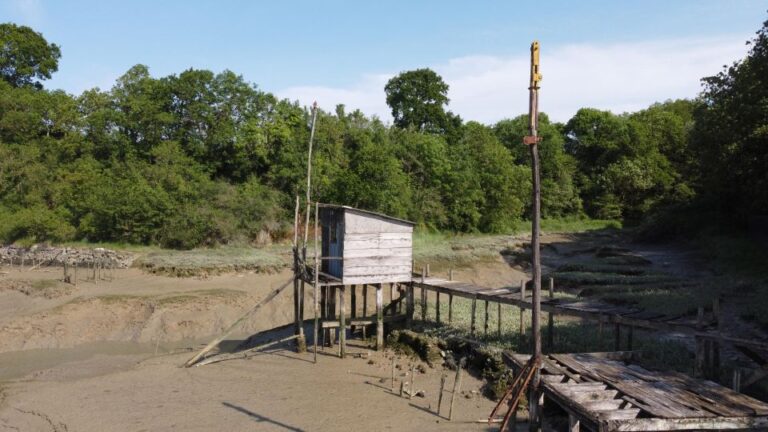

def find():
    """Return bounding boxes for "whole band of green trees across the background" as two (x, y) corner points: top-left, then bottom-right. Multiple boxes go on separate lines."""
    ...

(0, 16), (768, 248)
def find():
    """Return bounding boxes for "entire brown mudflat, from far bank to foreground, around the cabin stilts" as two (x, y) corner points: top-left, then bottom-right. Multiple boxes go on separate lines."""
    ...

(0, 255), (523, 432)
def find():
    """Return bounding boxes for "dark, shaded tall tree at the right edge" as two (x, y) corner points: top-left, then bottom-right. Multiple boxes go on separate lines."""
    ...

(692, 15), (768, 221)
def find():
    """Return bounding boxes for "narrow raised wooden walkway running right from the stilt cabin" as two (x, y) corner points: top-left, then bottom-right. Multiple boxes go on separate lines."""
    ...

(413, 275), (768, 349)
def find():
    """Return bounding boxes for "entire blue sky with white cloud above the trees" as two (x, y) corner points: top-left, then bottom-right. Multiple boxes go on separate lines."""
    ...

(0, 0), (768, 124)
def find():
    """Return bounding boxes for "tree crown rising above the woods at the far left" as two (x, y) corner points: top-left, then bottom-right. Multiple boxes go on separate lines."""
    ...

(0, 23), (61, 88)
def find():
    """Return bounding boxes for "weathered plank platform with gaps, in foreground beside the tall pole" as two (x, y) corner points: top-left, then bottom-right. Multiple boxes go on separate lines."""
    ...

(504, 351), (768, 432)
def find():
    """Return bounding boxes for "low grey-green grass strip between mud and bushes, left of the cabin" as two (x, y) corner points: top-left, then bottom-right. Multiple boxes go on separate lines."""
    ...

(134, 246), (289, 277)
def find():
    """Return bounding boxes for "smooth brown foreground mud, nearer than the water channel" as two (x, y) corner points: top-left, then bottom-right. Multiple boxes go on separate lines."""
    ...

(0, 348), (500, 431)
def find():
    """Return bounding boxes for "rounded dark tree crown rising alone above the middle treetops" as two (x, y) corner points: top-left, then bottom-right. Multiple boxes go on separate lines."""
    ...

(384, 68), (449, 132)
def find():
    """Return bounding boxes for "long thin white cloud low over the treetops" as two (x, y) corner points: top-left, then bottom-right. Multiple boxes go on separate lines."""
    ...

(277, 35), (749, 123)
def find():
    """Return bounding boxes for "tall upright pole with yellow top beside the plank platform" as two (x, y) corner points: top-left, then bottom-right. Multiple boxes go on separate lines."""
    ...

(523, 41), (541, 432)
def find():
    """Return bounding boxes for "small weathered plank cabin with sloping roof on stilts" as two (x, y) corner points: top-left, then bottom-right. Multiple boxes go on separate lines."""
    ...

(319, 204), (414, 285)
